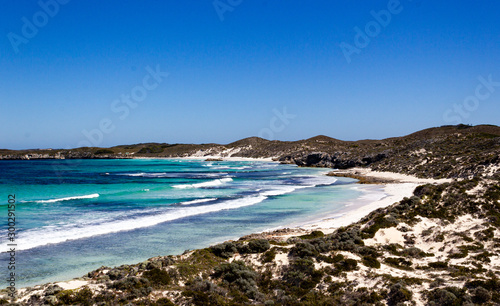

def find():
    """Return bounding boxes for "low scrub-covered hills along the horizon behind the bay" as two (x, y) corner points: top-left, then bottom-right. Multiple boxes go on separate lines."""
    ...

(0, 125), (500, 178)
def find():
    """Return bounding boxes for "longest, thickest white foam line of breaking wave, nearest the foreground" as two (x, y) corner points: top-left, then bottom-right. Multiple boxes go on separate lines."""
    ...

(18, 195), (267, 250)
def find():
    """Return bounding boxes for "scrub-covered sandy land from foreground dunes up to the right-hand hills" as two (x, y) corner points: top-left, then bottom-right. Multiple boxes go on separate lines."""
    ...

(5, 126), (500, 305)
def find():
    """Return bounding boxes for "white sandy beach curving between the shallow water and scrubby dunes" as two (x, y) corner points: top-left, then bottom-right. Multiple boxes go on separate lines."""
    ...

(13, 165), (451, 300)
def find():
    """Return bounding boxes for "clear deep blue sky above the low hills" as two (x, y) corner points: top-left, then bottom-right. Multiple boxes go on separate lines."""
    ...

(0, 0), (500, 149)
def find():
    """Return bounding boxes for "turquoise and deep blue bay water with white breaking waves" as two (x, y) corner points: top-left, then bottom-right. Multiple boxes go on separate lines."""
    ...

(0, 159), (362, 288)
